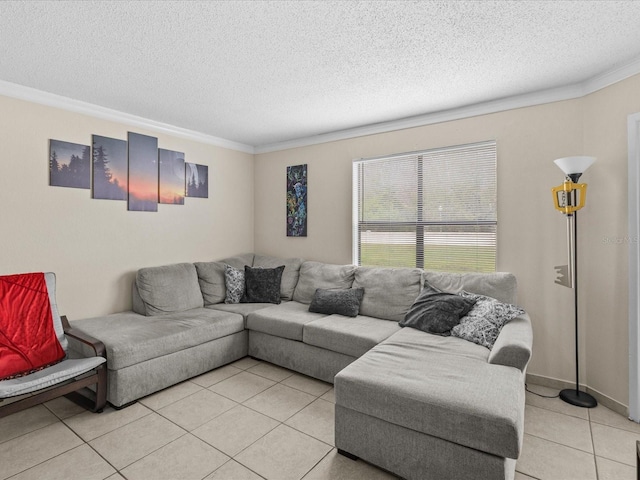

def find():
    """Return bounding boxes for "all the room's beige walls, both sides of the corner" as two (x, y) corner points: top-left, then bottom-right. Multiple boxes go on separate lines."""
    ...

(0, 75), (640, 404)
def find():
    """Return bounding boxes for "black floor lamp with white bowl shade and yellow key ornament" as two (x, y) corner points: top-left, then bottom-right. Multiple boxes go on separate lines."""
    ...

(551, 156), (598, 408)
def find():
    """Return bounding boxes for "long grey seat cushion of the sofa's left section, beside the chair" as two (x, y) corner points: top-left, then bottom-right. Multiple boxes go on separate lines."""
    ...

(72, 308), (244, 370)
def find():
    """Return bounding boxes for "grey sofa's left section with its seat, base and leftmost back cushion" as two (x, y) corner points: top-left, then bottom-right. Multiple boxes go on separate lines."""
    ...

(73, 264), (247, 407)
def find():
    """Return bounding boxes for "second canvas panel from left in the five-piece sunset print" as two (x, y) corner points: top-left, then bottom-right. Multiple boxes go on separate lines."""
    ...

(92, 135), (129, 200)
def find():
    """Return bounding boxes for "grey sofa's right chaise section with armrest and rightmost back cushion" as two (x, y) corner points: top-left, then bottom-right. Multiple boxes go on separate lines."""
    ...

(334, 272), (532, 480)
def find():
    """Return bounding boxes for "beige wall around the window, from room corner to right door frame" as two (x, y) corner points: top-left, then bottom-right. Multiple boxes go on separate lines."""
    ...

(255, 76), (640, 405)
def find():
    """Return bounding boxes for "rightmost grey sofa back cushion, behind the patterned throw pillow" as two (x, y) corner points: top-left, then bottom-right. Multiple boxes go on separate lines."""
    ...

(423, 270), (518, 305)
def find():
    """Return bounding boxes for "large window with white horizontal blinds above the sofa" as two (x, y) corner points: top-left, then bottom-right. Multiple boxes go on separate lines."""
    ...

(353, 141), (498, 272)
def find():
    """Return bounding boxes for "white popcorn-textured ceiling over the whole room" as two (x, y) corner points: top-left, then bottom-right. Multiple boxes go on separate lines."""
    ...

(0, 1), (640, 150)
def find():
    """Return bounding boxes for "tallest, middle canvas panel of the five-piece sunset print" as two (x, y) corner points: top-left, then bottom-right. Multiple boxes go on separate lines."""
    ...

(129, 132), (158, 212)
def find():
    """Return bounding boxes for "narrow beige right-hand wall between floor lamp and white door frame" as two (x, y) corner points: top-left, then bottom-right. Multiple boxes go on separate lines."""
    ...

(580, 75), (640, 404)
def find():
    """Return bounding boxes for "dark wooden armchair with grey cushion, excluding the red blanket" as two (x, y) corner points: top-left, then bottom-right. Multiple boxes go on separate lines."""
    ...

(0, 273), (107, 418)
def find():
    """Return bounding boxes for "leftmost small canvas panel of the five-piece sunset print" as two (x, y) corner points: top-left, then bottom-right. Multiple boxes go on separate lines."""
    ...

(49, 140), (91, 189)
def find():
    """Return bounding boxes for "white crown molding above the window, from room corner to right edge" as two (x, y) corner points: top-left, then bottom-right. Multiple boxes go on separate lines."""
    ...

(255, 58), (640, 154)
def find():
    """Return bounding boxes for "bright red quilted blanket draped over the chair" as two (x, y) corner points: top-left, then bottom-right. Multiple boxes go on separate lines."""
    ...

(0, 273), (65, 380)
